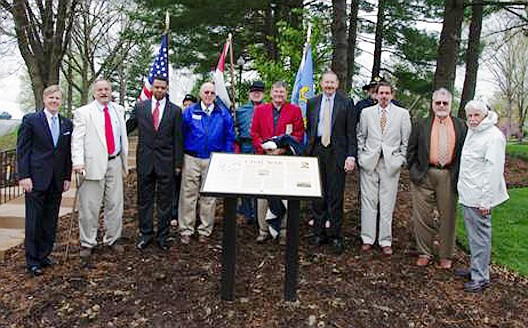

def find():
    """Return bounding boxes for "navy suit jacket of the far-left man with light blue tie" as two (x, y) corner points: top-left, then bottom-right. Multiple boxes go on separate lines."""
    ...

(17, 110), (73, 192)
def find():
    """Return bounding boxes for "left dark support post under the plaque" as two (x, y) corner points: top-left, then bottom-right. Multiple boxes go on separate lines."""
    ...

(220, 197), (237, 301)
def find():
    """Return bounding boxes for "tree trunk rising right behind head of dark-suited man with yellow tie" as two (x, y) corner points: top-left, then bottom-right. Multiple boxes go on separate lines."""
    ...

(332, 0), (348, 90)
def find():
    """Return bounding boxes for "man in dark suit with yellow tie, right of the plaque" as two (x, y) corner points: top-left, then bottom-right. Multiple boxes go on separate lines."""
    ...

(306, 71), (357, 254)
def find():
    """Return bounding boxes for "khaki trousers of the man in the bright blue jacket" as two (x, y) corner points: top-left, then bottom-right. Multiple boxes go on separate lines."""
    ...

(178, 154), (216, 236)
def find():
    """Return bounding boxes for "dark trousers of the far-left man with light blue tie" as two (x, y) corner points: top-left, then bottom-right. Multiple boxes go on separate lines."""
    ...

(24, 190), (62, 268)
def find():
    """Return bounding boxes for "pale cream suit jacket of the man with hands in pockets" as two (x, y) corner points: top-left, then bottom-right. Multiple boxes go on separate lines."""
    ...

(358, 103), (411, 175)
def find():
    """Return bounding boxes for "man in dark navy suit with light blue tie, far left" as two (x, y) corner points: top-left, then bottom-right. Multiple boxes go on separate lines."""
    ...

(17, 85), (73, 276)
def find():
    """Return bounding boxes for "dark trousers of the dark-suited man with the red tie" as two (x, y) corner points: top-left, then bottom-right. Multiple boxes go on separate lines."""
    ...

(138, 170), (174, 242)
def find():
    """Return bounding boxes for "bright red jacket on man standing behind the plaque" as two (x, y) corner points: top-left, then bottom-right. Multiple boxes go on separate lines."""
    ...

(251, 103), (304, 154)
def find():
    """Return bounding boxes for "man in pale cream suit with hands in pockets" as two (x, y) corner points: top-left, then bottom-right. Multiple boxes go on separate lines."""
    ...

(357, 82), (411, 256)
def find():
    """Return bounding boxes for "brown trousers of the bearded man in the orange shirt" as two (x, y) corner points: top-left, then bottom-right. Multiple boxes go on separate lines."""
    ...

(411, 168), (456, 259)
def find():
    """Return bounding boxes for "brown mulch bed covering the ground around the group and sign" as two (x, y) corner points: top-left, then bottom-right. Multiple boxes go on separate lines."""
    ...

(0, 159), (528, 328)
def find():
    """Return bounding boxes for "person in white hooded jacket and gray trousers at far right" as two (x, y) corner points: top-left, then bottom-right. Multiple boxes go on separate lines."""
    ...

(455, 100), (509, 293)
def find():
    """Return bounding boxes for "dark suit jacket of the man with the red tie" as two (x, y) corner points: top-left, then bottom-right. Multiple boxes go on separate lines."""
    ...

(126, 98), (183, 175)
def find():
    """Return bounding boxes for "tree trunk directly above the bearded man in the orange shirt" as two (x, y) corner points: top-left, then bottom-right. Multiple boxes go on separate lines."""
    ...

(433, 0), (464, 91)
